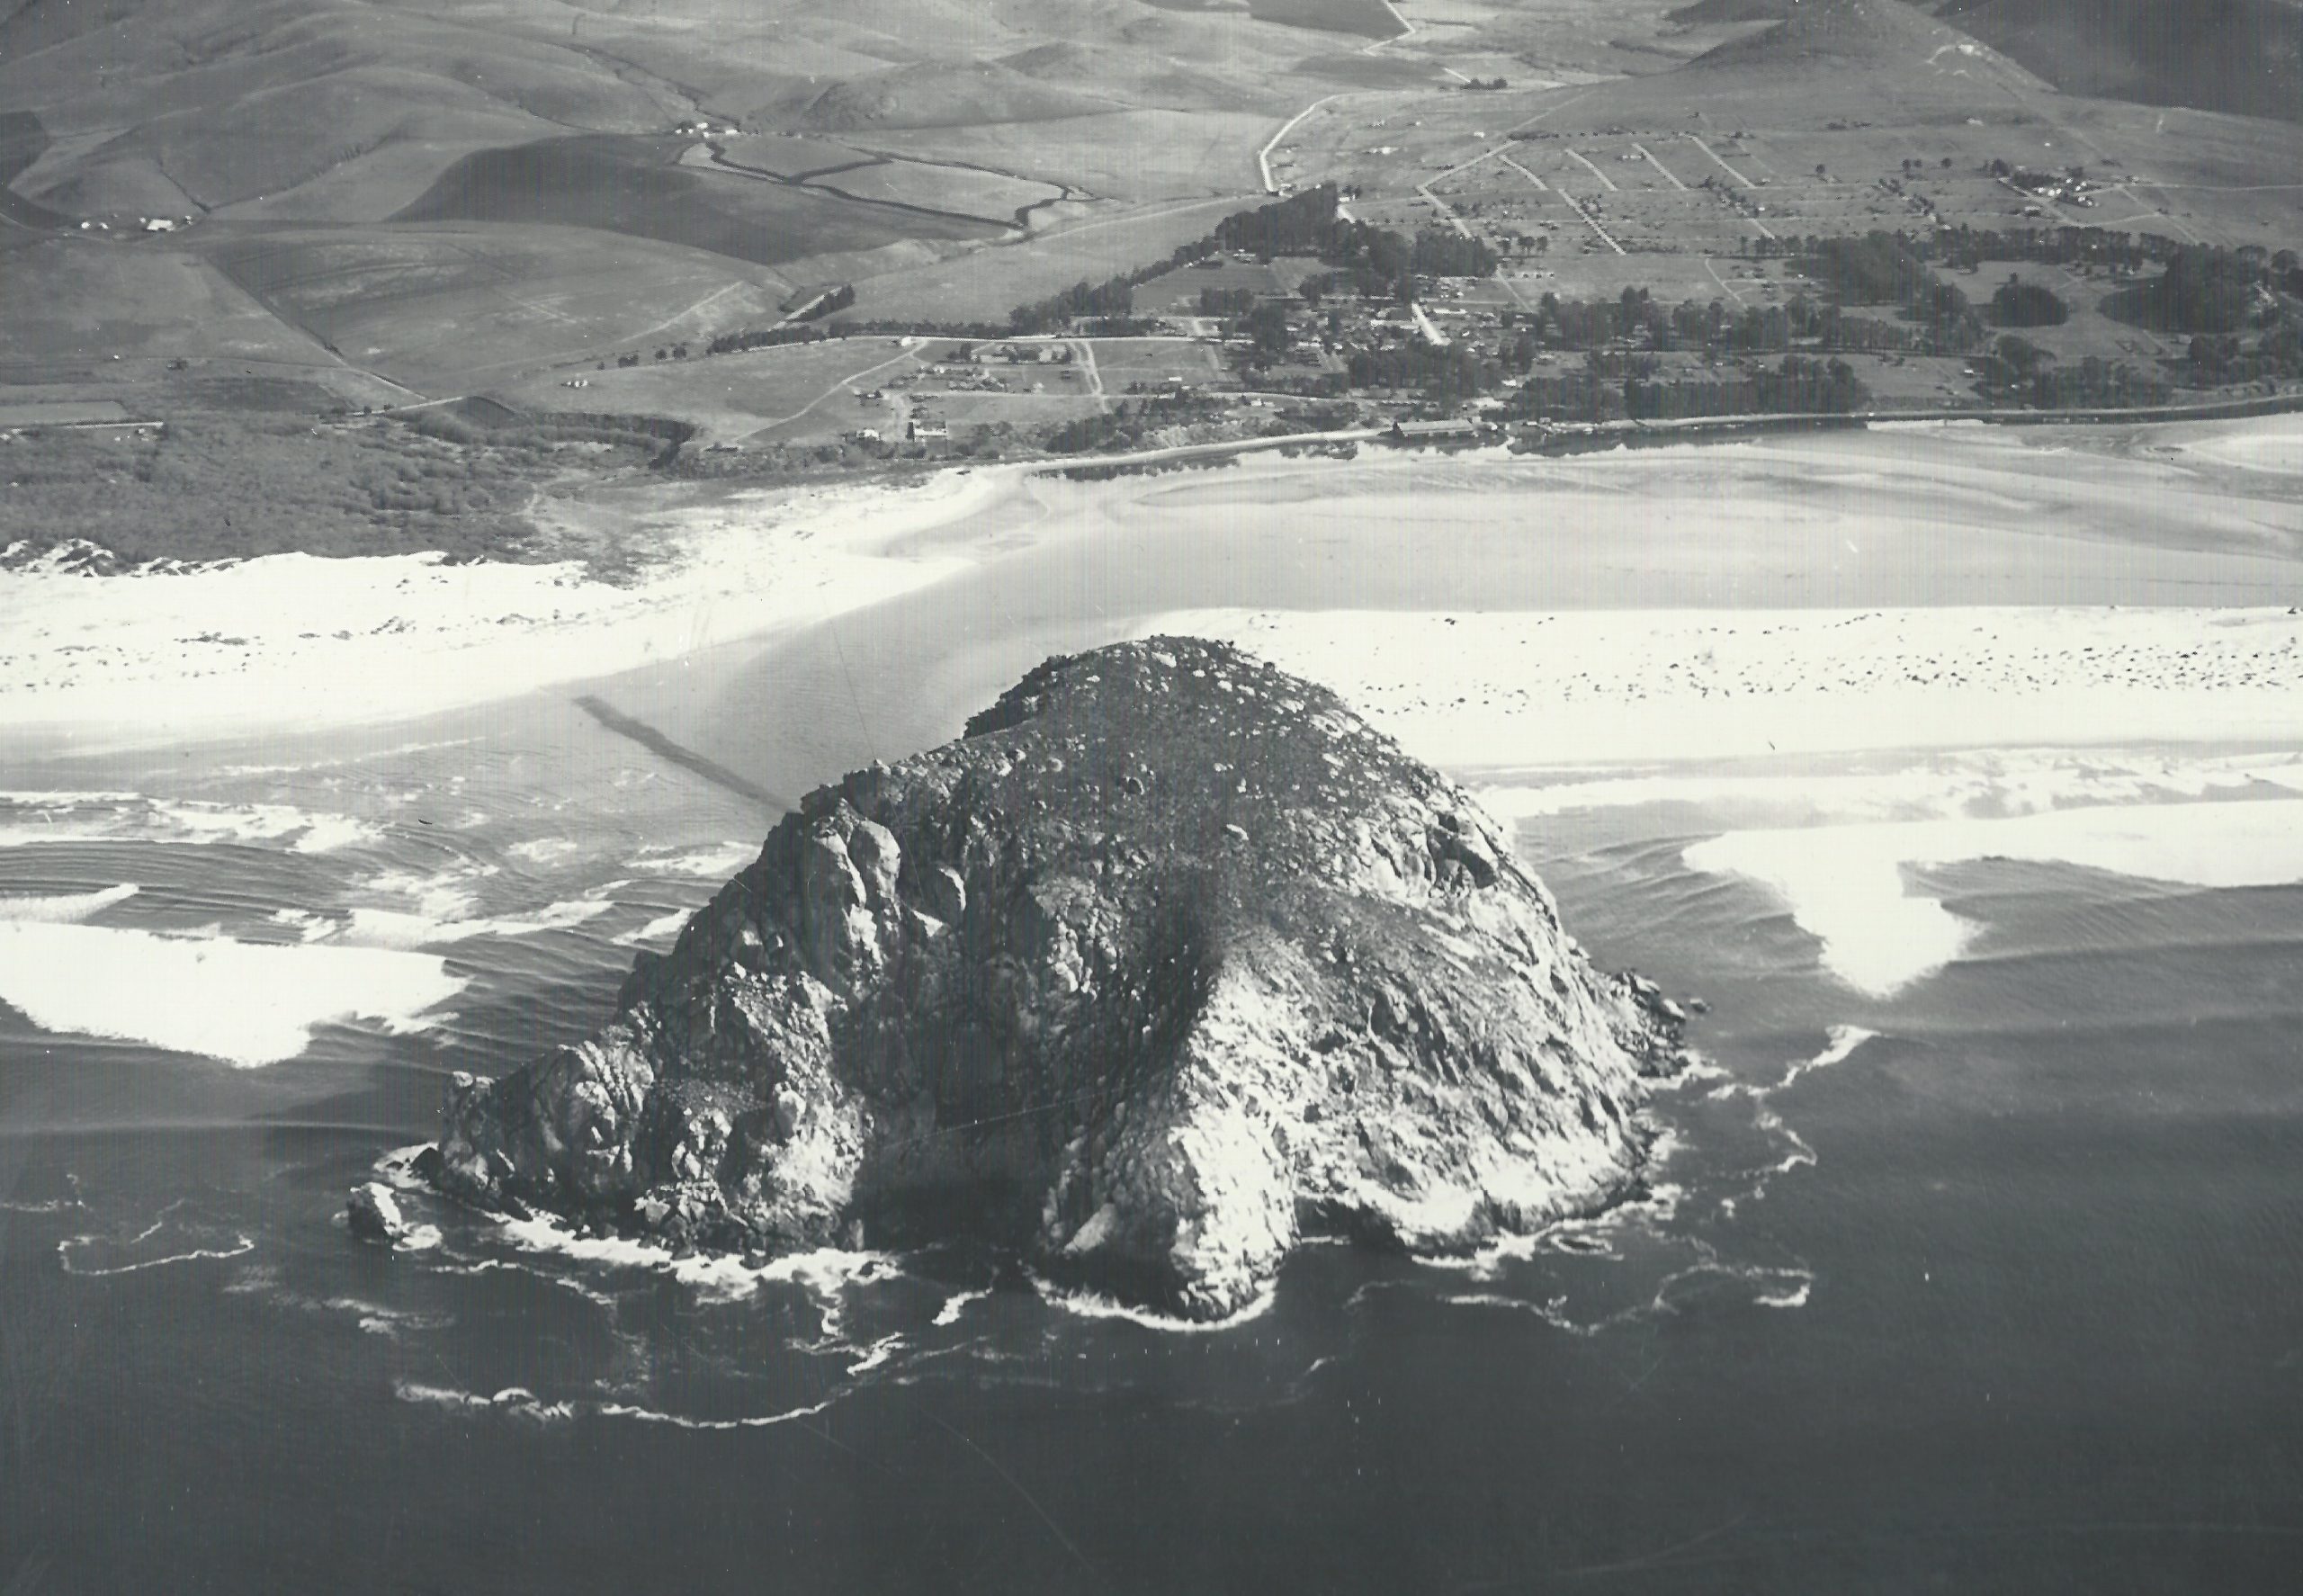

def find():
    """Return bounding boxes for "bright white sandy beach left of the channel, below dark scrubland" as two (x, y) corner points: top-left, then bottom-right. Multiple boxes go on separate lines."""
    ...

(0, 472), (1007, 749)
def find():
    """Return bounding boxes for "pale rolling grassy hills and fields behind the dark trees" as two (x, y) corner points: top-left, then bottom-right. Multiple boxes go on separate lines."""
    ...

(13, 0), (2303, 435)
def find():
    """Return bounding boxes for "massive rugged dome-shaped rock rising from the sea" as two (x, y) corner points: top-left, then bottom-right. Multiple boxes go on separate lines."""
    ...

(440, 638), (1677, 1320)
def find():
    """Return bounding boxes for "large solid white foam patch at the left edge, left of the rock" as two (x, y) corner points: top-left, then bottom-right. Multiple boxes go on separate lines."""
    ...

(0, 921), (465, 1069)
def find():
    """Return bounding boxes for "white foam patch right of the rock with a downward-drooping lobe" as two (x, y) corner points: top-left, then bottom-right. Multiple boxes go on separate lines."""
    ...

(1683, 799), (2303, 997)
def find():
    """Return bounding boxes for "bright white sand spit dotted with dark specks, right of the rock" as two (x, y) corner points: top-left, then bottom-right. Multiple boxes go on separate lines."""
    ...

(1144, 608), (2303, 769)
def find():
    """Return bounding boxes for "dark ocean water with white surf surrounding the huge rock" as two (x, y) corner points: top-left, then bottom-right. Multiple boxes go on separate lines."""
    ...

(0, 604), (2303, 1593)
